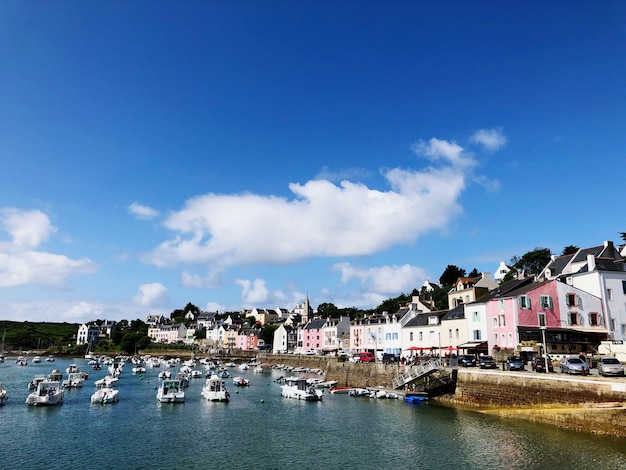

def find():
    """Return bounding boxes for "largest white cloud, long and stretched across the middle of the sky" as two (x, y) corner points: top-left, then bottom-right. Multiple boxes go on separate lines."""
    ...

(144, 139), (482, 268)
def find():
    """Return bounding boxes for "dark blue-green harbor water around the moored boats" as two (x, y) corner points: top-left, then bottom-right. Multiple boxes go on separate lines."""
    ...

(0, 357), (626, 470)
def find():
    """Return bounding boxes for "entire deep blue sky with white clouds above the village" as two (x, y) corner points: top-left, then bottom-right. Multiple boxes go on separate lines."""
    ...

(0, 0), (626, 322)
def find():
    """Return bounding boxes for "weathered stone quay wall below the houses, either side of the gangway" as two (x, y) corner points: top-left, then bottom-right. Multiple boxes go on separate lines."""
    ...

(261, 354), (626, 438)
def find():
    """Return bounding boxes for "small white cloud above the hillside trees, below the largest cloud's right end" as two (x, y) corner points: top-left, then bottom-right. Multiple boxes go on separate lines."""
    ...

(332, 263), (426, 296)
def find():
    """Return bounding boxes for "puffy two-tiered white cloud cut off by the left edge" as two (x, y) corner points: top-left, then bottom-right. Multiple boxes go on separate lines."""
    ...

(0, 208), (98, 288)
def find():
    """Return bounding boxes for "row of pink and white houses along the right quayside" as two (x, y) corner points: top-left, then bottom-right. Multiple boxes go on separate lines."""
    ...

(273, 241), (626, 357)
